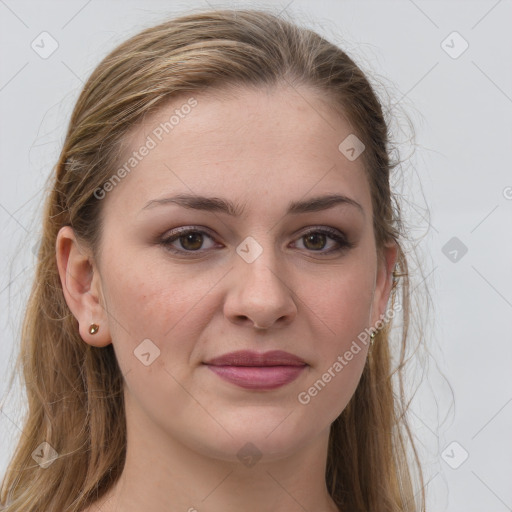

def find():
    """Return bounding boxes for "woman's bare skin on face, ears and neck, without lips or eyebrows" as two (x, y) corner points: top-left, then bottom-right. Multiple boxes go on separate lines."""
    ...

(56, 87), (397, 512)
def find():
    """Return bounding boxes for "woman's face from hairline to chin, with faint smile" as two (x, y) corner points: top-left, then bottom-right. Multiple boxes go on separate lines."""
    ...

(59, 88), (396, 460)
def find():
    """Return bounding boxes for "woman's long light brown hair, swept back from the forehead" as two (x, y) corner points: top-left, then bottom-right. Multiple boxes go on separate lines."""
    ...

(0, 9), (425, 512)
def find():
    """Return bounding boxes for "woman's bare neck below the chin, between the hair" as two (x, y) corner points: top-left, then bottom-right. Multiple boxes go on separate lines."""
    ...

(94, 408), (339, 512)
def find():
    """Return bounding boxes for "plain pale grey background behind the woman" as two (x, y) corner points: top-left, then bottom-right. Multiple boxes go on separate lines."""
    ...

(0, 0), (512, 512)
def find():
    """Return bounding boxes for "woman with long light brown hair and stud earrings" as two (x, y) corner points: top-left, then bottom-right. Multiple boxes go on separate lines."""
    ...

(0, 10), (424, 512)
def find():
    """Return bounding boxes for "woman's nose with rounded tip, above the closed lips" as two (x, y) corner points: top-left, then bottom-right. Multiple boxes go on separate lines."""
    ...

(224, 243), (297, 330)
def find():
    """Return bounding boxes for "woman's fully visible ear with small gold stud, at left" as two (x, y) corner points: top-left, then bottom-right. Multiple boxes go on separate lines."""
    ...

(55, 226), (112, 347)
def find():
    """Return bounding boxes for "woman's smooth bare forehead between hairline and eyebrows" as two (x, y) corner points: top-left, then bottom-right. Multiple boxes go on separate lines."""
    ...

(101, 83), (370, 218)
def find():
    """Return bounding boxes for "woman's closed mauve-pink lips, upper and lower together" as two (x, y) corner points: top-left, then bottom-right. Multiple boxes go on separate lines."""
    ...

(204, 350), (308, 390)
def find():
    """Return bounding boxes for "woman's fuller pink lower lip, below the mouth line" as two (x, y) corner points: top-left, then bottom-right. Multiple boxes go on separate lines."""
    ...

(207, 365), (306, 389)
